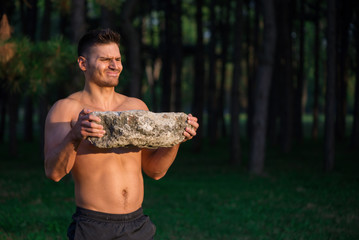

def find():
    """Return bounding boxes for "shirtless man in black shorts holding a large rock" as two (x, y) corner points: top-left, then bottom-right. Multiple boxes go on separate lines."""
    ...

(44, 30), (199, 240)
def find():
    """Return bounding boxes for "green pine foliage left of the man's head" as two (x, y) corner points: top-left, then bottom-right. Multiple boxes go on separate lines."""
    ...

(0, 35), (80, 101)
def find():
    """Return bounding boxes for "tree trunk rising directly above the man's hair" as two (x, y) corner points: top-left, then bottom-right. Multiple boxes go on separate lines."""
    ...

(70, 0), (86, 44)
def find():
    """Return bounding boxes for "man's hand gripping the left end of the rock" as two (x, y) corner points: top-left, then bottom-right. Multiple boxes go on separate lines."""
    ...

(71, 109), (106, 141)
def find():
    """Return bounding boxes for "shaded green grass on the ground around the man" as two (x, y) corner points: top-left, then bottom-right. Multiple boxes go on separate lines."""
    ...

(0, 141), (359, 240)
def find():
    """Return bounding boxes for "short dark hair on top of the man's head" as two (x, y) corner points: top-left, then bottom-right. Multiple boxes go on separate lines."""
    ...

(77, 28), (120, 56)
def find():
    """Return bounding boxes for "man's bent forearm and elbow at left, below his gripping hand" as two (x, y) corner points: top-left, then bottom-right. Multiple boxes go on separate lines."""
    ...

(45, 134), (80, 182)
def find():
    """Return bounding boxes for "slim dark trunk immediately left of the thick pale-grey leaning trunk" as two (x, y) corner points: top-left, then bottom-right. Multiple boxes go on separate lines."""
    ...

(230, 0), (243, 165)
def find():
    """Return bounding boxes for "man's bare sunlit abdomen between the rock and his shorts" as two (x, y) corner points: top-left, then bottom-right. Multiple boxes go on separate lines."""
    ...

(72, 140), (144, 214)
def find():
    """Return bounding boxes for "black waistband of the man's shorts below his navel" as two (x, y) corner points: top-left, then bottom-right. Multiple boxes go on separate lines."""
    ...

(75, 207), (143, 222)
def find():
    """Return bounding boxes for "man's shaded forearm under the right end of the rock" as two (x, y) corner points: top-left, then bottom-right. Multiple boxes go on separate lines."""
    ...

(142, 144), (179, 180)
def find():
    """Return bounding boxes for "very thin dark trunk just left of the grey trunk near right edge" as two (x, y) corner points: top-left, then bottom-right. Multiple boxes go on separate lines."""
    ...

(312, 0), (320, 139)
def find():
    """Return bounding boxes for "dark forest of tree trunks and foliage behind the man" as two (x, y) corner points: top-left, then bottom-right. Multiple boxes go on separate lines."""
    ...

(0, 0), (359, 239)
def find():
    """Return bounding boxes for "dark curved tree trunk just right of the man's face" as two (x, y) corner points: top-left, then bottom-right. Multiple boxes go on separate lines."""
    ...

(121, 0), (142, 98)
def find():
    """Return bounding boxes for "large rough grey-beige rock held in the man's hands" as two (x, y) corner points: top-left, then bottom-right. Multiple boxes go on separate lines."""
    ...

(88, 110), (191, 148)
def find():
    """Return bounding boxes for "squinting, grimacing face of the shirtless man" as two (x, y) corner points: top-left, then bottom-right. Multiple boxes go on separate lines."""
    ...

(80, 43), (123, 87)
